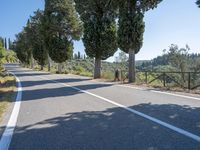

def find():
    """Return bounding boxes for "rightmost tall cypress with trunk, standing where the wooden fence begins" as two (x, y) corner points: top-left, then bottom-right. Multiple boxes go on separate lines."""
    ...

(116, 0), (162, 82)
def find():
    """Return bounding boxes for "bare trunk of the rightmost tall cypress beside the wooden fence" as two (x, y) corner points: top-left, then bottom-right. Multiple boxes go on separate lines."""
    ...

(128, 49), (135, 83)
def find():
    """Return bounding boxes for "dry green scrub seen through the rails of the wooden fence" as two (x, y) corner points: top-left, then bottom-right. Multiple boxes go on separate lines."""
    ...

(120, 71), (200, 90)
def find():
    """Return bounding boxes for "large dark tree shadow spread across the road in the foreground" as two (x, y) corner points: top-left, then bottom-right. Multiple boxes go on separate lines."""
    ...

(3, 103), (200, 150)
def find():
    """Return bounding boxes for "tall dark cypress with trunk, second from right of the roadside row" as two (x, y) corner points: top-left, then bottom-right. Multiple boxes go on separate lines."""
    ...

(75, 0), (117, 78)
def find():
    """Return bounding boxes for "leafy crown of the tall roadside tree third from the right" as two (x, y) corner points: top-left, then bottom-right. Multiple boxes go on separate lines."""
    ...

(44, 0), (82, 72)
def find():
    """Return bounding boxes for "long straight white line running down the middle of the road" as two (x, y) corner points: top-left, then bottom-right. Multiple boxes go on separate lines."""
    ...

(39, 77), (200, 142)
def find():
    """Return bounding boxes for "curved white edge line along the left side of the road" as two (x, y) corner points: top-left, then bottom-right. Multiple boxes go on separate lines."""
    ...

(0, 73), (22, 150)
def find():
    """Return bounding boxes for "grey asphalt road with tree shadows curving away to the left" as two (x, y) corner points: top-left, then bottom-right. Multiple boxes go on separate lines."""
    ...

(0, 65), (200, 150)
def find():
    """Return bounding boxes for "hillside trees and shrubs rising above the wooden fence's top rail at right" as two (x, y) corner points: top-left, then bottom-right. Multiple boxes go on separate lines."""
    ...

(137, 44), (200, 72)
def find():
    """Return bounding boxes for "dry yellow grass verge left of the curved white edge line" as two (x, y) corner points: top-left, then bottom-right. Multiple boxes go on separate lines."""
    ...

(0, 75), (16, 121)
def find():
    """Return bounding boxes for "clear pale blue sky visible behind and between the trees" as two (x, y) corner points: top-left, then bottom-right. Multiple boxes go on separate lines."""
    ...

(0, 0), (200, 61)
